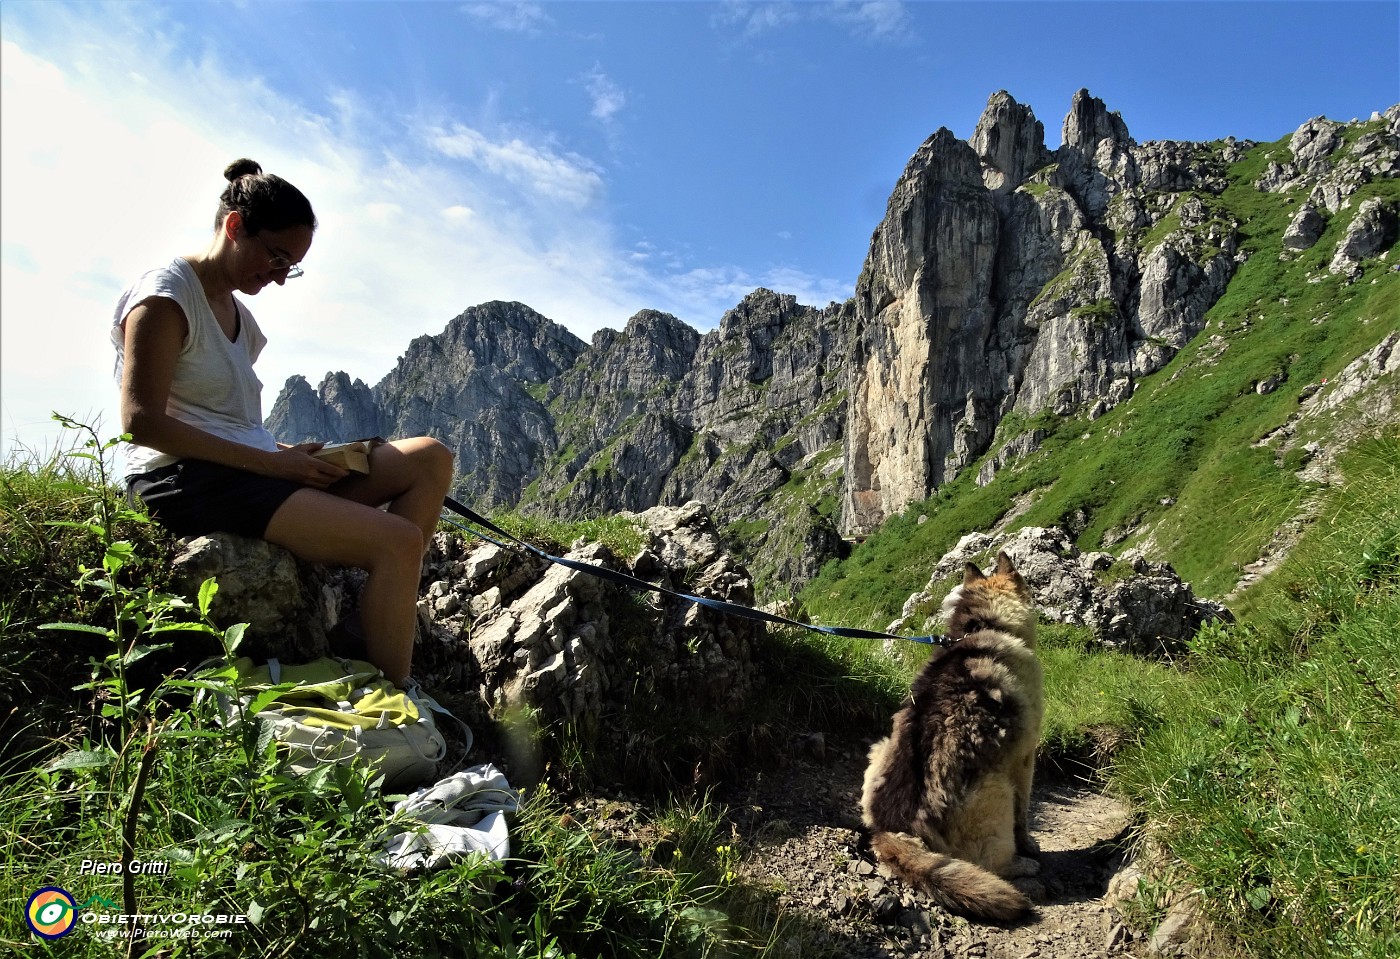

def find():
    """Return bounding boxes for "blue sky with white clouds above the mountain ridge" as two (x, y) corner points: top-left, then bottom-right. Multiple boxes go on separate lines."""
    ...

(0, 0), (1400, 451)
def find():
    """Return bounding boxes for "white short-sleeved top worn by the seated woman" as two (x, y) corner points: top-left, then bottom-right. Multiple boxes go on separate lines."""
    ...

(111, 258), (277, 475)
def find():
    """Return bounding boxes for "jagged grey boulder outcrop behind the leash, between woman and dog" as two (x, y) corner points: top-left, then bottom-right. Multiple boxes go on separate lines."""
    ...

(424, 503), (760, 745)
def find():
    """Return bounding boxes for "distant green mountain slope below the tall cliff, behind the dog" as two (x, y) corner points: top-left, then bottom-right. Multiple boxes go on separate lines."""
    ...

(802, 134), (1400, 624)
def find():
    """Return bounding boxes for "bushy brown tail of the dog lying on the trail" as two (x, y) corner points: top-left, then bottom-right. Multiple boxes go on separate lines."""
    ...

(871, 833), (1032, 923)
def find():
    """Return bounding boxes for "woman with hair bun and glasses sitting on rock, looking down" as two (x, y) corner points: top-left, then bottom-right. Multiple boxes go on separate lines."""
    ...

(112, 160), (452, 685)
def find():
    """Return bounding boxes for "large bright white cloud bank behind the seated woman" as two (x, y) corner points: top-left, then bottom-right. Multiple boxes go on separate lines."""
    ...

(0, 4), (848, 454)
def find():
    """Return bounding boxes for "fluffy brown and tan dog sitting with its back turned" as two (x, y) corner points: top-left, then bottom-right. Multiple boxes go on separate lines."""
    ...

(861, 553), (1044, 921)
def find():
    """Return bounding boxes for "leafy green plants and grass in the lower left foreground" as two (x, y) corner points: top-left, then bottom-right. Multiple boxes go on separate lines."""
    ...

(0, 414), (773, 959)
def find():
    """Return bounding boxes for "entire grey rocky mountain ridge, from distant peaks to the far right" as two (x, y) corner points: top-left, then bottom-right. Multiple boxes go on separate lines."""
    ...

(269, 90), (1400, 590)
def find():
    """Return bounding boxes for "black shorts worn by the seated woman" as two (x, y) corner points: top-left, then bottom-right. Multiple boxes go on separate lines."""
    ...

(126, 459), (309, 539)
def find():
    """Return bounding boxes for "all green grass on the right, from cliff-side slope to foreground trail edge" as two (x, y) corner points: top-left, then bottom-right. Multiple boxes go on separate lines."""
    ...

(802, 128), (1400, 959)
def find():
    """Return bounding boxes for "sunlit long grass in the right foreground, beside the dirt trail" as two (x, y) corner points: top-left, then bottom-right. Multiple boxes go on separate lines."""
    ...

(1113, 430), (1400, 959)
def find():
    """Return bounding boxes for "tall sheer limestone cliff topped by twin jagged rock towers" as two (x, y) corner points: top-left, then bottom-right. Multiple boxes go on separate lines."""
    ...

(844, 90), (1246, 532)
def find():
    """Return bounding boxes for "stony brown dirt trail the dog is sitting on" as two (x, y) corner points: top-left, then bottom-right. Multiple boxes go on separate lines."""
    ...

(717, 738), (1145, 959)
